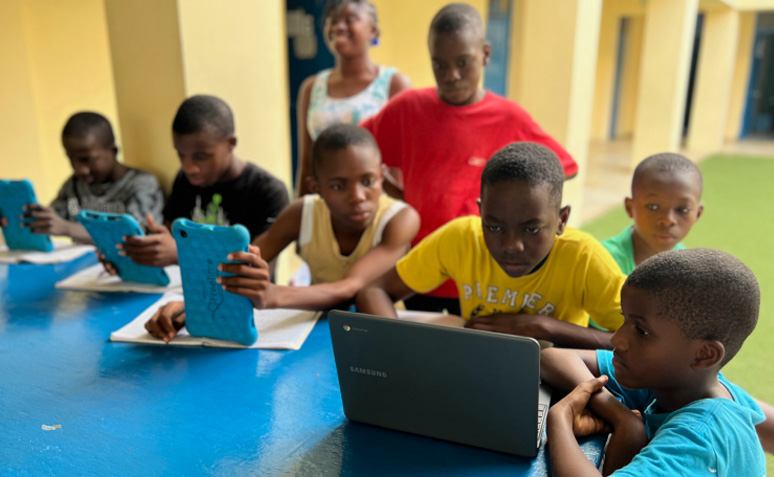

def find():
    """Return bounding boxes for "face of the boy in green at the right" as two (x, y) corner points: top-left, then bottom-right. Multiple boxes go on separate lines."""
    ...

(624, 172), (704, 253)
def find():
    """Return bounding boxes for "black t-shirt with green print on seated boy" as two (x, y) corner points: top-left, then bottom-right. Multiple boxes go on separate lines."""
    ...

(164, 163), (288, 239)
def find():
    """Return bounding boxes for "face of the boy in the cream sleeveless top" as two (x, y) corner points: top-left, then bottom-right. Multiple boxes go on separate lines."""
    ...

(311, 145), (384, 231)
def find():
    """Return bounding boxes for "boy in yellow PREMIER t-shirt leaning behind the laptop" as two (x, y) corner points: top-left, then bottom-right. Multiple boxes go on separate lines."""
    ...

(356, 142), (625, 348)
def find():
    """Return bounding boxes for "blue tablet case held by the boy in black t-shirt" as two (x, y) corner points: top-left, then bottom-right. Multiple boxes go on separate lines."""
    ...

(78, 210), (169, 286)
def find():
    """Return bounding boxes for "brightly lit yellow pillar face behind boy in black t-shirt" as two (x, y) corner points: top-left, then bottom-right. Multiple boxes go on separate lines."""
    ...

(177, 0), (290, 185)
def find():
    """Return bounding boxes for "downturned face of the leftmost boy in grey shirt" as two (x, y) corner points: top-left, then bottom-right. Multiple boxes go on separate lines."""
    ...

(62, 134), (118, 184)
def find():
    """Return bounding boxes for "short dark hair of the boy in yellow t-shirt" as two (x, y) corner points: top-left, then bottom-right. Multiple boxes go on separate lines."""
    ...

(481, 142), (564, 207)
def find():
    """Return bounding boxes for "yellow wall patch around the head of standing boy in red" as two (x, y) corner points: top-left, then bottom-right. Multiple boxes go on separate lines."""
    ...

(371, 0), (489, 88)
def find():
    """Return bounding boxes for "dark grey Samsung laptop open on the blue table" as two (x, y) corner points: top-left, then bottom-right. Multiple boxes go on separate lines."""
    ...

(328, 311), (550, 457)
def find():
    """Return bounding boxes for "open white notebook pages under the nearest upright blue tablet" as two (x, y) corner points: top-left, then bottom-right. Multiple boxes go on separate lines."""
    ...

(110, 293), (321, 349)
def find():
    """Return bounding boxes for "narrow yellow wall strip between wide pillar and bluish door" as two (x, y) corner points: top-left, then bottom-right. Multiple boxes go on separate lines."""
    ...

(591, 2), (621, 141)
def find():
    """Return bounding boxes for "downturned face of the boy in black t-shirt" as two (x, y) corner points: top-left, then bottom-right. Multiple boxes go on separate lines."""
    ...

(172, 128), (236, 187)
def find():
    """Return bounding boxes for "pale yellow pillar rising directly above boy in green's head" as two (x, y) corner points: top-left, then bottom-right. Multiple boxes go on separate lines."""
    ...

(632, 0), (699, 164)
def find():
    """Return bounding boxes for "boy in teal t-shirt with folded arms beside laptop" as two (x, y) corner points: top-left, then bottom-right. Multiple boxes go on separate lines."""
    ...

(540, 249), (766, 477)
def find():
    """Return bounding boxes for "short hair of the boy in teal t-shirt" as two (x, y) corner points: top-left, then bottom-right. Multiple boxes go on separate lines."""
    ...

(625, 248), (761, 366)
